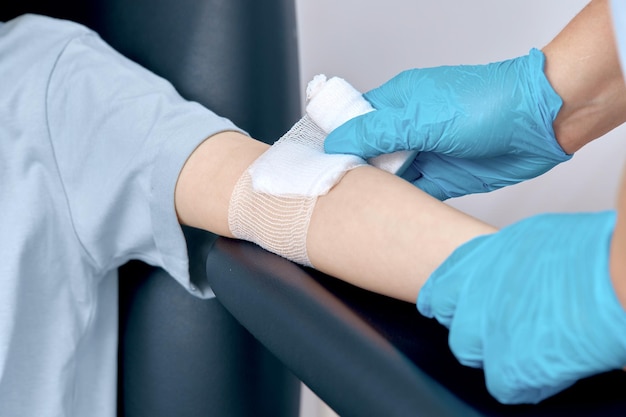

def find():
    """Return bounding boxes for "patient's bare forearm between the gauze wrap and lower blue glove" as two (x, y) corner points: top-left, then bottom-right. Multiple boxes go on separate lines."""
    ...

(307, 162), (495, 302)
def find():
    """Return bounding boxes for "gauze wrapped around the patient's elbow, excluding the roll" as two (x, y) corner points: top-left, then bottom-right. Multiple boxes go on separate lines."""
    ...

(228, 115), (365, 266)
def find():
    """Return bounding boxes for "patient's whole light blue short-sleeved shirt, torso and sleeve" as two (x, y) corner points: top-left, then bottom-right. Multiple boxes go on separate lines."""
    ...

(0, 15), (241, 417)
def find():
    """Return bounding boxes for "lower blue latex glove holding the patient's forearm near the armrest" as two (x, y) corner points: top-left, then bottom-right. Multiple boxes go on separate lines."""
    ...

(417, 211), (626, 403)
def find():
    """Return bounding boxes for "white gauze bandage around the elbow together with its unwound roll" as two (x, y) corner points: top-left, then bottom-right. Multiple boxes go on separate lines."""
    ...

(228, 75), (406, 266)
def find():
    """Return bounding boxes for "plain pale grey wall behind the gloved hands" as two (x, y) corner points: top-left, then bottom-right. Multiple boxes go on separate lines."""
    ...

(296, 0), (626, 416)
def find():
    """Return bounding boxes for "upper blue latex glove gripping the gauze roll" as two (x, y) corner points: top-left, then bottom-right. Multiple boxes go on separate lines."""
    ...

(324, 49), (570, 200)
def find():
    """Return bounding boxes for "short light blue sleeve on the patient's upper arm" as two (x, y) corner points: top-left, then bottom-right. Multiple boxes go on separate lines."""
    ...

(46, 27), (238, 297)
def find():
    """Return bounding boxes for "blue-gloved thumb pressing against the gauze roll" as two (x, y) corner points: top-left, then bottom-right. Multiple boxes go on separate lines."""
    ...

(324, 109), (411, 159)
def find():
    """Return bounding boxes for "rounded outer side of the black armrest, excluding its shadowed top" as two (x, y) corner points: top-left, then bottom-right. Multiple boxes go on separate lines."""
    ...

(207, 239), (472, 417)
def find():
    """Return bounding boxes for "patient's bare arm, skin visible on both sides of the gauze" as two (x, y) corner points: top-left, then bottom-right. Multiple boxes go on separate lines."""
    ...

(176, 132), (495, 302)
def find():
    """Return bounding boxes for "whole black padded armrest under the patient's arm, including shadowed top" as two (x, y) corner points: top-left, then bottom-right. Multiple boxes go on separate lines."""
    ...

(207, 238), (626, 417)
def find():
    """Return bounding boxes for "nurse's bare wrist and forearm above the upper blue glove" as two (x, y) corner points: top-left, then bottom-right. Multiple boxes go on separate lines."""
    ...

(543, 0), (626, 153)
